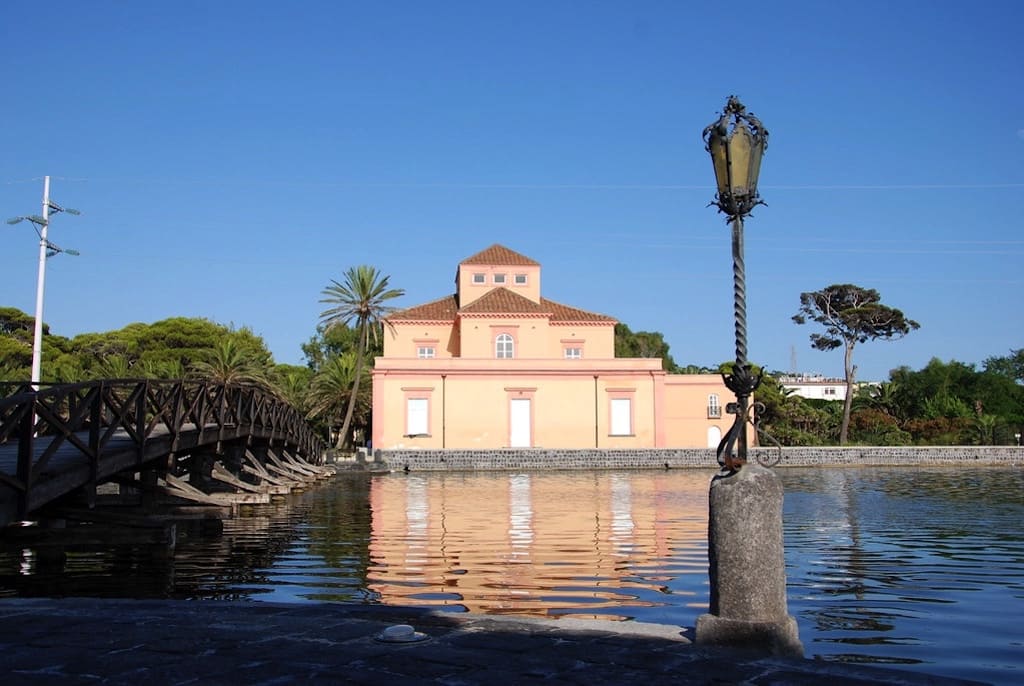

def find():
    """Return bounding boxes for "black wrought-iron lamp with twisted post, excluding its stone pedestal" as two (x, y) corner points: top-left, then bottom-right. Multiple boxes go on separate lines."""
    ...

(703, 95), (768, 472)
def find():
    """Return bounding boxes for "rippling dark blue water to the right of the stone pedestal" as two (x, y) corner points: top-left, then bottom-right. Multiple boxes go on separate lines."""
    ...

(780, 468), (1024, 683)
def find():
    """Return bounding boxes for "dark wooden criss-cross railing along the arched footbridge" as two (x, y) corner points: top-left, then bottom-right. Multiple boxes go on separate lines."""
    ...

(0, 379), (326, 513)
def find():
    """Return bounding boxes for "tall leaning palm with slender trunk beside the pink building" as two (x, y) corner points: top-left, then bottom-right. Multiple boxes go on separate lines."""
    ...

(321, 264), (406, 448)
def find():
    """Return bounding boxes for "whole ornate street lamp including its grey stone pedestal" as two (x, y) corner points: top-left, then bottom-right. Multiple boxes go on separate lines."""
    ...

(695, 96), (804, 656)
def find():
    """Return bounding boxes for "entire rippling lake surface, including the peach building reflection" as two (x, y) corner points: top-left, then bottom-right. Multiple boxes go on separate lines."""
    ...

(0, 468), (1024, 684)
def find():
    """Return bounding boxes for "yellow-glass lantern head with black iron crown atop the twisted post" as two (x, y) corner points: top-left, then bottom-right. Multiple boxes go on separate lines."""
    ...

(703, 95), (768, 221)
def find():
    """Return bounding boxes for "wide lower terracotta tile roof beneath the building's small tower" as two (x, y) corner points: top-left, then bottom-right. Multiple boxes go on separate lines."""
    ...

(387, 288), (615, 324)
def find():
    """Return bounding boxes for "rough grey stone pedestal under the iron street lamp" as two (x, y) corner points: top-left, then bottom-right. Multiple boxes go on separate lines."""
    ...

(696, 464), (804, 656)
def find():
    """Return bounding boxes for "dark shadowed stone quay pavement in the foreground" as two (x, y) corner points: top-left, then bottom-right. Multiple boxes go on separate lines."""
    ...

(0, 598), (983, 686)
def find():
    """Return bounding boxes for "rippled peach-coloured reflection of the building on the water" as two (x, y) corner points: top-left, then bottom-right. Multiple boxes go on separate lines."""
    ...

(368, 472), (707, 618)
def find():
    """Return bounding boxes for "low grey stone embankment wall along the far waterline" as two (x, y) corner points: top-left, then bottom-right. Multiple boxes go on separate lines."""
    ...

(373, 445), (1024, 471)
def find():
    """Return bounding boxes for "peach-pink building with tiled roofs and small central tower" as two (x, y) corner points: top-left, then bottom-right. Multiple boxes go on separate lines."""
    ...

(373, 245), (732, 449)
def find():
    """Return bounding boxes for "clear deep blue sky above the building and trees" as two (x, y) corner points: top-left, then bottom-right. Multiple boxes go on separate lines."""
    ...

(0, 0), (1024, 380)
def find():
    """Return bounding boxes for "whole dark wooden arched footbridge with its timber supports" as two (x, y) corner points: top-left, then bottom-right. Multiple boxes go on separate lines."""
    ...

(0, 380), (332, 526)
